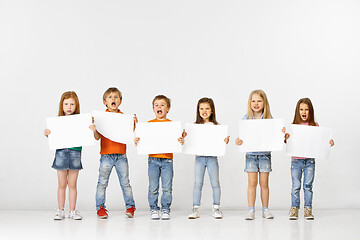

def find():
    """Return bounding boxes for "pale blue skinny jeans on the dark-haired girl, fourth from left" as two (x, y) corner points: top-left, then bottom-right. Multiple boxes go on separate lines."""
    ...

(193, 156), (221, 206)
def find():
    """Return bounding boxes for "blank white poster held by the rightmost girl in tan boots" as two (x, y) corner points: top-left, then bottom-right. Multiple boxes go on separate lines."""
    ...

(286, 124), (332, 159)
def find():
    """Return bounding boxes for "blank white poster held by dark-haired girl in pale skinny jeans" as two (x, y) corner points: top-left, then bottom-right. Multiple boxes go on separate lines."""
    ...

(183, 123), (228, 156)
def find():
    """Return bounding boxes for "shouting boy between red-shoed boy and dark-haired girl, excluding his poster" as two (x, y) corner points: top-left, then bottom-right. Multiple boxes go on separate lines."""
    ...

(135, 95), (186, 220)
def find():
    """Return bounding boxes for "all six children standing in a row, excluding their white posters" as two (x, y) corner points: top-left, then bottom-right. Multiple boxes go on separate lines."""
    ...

(44, 88), (334, 220)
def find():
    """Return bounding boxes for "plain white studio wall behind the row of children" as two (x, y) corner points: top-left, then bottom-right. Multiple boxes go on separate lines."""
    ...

(0, 0), (360, 210)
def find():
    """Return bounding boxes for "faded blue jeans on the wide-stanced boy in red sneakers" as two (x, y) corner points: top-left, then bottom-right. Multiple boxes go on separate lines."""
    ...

(96, 154), (135, 210)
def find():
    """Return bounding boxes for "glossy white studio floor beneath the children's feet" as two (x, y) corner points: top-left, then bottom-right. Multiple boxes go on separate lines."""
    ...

(0, 209), (360, 240)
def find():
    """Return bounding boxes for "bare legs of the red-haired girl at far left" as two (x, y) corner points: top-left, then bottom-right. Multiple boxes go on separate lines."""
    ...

(57, 170), (79, 211)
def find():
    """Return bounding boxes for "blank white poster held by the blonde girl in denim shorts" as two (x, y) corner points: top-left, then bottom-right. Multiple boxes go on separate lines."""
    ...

(239, 119), (284, 152)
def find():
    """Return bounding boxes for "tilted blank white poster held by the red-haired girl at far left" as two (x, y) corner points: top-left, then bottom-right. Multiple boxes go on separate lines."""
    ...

(46, 113), (94, 150)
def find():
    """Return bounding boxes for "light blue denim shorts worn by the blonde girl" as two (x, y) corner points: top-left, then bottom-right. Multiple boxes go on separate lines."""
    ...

(244, 153), (272, 172)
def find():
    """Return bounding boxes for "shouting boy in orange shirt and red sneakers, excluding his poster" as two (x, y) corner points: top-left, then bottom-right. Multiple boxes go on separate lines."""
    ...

(90, 88), (137, 218)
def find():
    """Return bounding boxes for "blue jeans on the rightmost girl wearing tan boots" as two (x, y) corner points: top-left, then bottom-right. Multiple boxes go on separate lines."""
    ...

(291, 158), (315, 208)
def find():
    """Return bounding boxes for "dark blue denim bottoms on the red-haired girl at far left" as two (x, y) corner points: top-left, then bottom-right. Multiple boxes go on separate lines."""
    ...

(51, 148), (82, 170)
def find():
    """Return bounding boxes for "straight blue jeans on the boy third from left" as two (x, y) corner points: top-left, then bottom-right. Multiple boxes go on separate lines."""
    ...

(148, 157), (174, 212)
